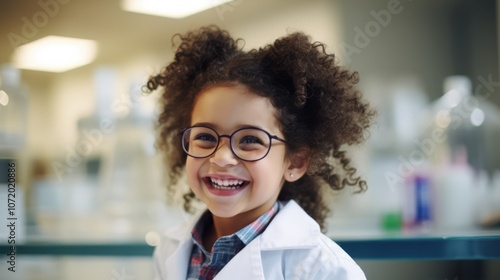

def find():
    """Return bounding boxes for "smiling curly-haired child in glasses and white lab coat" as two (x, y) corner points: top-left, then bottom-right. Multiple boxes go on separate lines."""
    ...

(147, 26), (374, 280)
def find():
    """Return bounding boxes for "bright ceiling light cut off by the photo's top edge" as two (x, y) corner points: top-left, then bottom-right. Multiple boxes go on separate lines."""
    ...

(121, 0), (232, 18)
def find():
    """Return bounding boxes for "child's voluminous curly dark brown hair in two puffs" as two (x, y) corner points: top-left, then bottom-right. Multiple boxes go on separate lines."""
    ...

(147, 26), (375, 230)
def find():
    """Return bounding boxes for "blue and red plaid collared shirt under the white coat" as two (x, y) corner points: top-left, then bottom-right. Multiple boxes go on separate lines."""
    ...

(187, 202), (280, 280)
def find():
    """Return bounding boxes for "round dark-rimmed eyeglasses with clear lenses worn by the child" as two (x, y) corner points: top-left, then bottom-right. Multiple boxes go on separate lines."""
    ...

(181, 126), (286, 161)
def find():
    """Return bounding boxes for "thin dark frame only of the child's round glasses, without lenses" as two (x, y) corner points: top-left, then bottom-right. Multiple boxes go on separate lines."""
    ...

(180, 125), (286, 162)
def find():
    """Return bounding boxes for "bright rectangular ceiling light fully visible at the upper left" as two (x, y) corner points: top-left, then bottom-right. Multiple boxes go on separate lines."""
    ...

(13, 36), (97, 72)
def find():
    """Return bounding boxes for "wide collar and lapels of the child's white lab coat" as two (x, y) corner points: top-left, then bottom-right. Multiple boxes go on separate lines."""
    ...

(162, 200), (321, 280)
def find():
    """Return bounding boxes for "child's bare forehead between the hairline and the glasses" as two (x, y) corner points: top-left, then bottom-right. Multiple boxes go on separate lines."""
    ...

(191, 84), (278, 133)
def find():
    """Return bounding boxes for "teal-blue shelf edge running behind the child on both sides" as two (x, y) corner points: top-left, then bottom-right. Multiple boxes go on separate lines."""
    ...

(0, 232), (500, 260)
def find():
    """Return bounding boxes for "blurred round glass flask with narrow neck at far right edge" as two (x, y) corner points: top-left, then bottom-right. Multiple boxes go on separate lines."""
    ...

(420, 76), (500, 176)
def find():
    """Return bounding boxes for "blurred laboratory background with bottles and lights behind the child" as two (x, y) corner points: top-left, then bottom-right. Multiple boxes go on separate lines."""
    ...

(0, 0), (500, 279)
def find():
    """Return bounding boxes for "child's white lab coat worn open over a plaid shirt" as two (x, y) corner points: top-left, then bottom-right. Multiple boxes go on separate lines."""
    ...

(154, 200), (366, 280)
